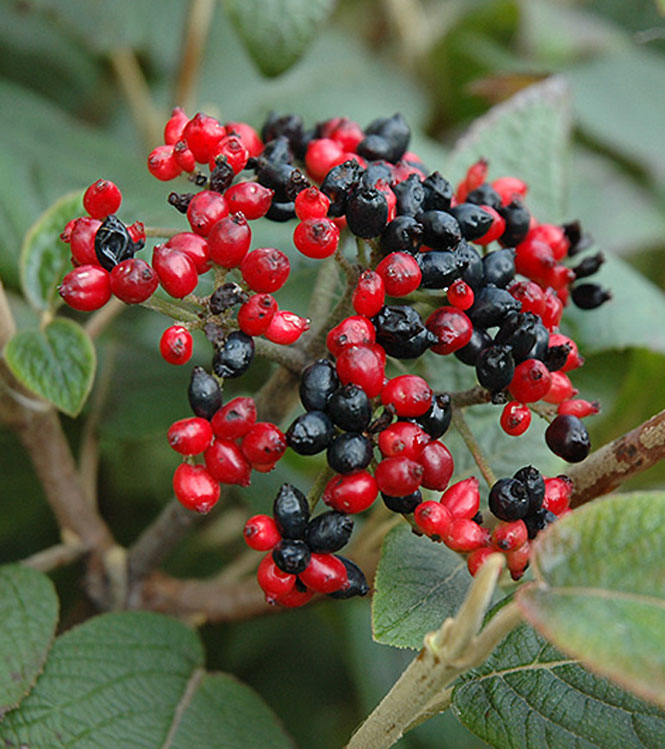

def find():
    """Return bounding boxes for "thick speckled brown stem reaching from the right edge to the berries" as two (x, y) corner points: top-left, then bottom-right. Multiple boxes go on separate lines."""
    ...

(566, 410), (665, 507)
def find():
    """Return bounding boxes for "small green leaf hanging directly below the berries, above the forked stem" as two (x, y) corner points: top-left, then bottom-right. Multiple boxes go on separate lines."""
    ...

(372, 524), (471, 650)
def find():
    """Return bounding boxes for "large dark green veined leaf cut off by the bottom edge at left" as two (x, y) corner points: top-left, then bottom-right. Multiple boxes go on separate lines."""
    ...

(0, 612), (290, 749)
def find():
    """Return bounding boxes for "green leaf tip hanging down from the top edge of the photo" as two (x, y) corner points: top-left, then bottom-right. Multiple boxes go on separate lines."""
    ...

(224, 0), (333, 76)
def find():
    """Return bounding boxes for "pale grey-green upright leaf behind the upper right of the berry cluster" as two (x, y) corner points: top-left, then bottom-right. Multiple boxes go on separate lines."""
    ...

(445, 78), (570, 222)
